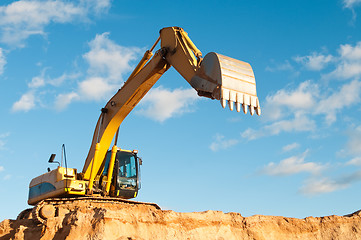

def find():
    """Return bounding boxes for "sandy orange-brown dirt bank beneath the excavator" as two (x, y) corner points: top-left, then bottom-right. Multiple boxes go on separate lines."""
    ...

(0, 203), (361, 240)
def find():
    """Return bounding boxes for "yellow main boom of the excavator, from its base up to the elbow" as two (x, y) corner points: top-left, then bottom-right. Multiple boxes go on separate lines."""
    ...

(82, 52), (170, 180)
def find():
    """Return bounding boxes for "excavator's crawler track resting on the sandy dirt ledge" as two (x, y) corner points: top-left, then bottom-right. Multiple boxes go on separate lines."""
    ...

(32, 196), (161, 224)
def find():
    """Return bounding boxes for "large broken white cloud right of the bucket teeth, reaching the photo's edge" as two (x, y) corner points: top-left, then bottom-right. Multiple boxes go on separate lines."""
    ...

(241, 80), (361, 140)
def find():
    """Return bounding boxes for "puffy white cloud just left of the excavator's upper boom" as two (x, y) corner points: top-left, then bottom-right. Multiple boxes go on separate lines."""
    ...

(56, 33), (140, 105)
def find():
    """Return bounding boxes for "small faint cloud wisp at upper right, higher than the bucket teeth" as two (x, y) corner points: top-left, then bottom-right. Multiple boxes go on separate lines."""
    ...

(294, 52), (334, 71)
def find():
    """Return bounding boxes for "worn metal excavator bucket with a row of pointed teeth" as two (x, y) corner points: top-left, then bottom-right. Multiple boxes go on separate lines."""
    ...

(190, 52), (261, 115)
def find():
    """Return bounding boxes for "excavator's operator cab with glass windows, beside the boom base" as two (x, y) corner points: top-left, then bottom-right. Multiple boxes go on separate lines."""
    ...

(103, 150), (142, 199)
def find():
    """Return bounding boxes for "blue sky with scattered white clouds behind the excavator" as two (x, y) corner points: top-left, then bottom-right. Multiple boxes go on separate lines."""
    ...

(0, 0), (361, 220)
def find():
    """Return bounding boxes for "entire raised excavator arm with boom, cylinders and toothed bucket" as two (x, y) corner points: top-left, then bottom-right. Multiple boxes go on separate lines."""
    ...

(82, 27), (261, 194)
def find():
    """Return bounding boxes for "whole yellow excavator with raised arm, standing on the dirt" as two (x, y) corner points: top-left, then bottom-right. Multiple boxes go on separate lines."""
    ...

(20, 27), (261, 222)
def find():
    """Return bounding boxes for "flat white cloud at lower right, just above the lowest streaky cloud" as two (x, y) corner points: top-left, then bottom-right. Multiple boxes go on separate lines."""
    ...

(262, 151), (325, 176)
